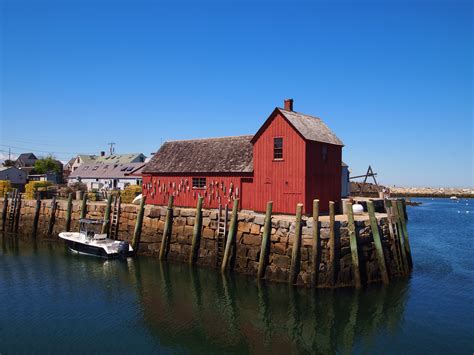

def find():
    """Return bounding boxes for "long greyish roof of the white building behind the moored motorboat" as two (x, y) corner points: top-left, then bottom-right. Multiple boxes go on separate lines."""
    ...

(69, 163), (145, 179)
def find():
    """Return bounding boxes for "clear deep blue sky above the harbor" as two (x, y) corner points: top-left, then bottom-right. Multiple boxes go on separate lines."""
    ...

(0, 0), (474, 187)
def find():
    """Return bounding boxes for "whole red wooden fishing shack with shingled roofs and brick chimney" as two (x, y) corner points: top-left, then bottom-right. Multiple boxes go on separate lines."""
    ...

(143, 100), (343, 213)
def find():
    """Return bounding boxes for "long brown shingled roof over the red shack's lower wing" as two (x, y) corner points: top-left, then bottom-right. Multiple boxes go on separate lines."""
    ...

(143, 136), (253, 174)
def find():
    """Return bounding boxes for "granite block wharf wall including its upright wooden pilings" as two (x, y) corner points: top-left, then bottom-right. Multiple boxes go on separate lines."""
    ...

(0, 198), (412, 288)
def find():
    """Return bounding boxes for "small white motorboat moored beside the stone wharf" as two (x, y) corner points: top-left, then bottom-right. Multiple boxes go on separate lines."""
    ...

(59, 218), (133, 259)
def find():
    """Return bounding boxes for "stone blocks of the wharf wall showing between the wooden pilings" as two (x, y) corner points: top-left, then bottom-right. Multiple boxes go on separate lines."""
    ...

(0, 200), (408, 287)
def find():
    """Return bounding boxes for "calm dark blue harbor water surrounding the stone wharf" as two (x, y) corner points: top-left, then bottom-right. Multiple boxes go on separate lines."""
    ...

(0, 199), (474, 354)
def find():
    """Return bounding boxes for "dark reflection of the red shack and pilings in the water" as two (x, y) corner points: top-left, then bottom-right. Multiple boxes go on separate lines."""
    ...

(135, 263), (407, 353)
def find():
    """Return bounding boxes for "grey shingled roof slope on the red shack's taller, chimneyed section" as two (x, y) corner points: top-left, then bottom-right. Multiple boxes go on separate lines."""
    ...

(279, 108), (344, 145)
